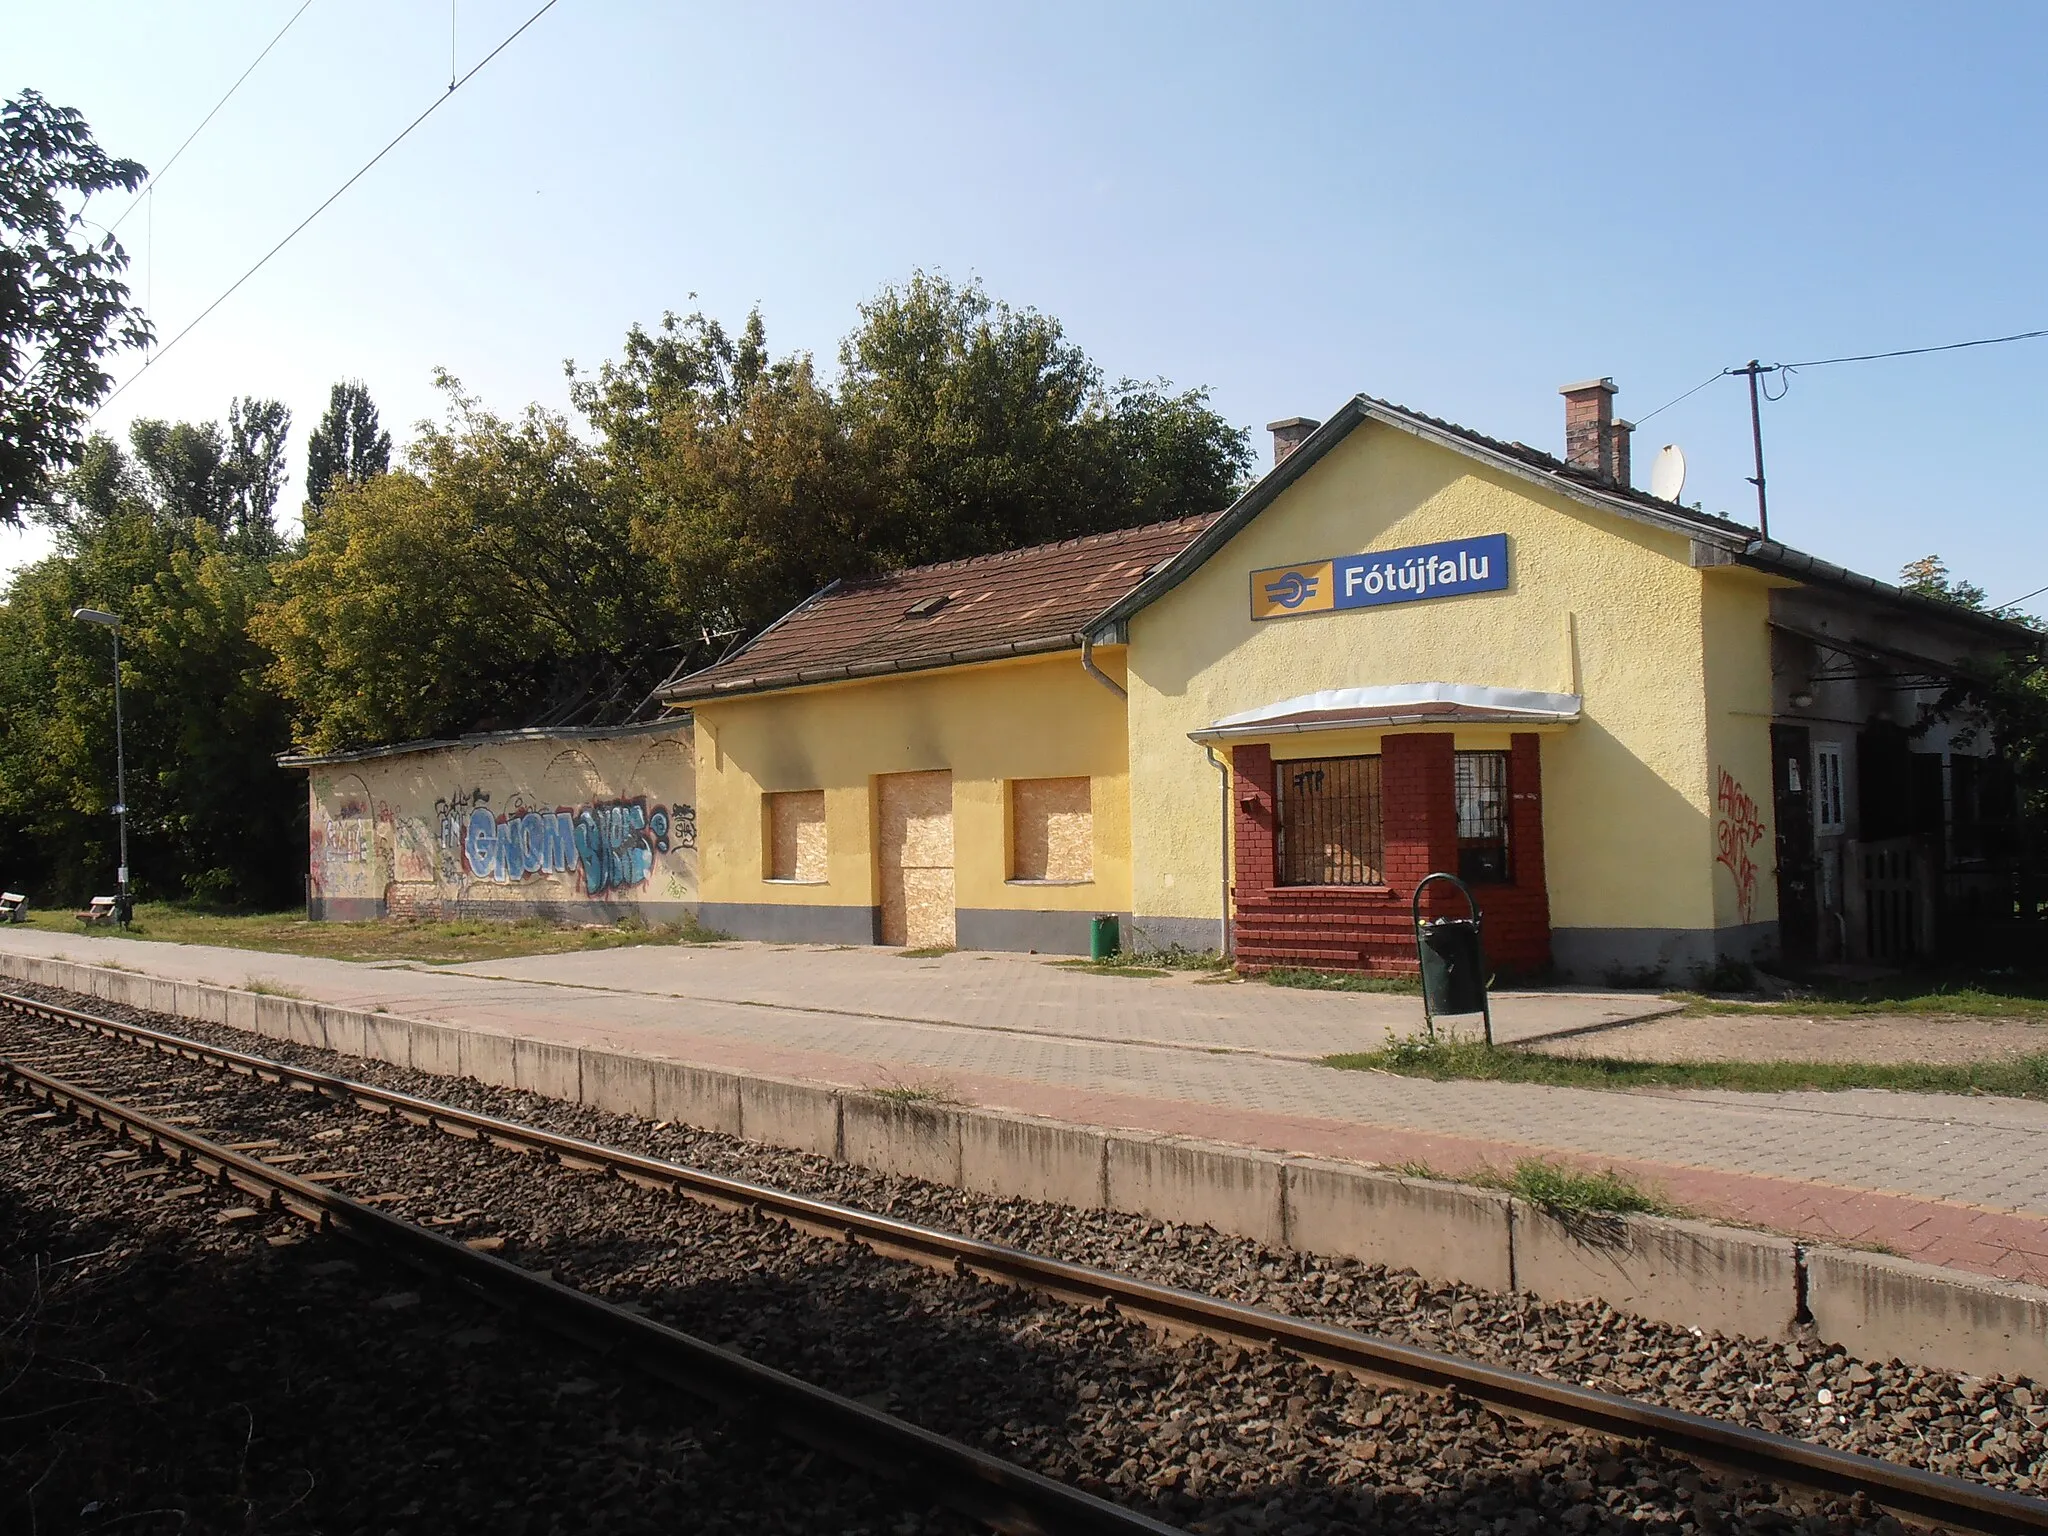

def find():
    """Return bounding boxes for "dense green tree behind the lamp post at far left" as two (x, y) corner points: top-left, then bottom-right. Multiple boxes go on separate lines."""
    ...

(0, 512), (305, 905)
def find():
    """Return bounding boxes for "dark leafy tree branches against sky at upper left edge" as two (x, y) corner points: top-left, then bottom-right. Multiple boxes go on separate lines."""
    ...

(0, 90), (152, 524)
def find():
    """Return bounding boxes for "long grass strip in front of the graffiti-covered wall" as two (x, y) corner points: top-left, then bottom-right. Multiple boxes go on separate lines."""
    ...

(14, 901), (729, 965)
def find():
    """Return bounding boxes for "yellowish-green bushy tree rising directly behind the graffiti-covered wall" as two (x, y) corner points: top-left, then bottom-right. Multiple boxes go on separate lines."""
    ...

(254, 377), (678, 750)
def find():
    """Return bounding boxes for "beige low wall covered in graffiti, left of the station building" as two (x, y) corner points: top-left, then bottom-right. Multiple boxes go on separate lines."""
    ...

(297, 721), (696, 922)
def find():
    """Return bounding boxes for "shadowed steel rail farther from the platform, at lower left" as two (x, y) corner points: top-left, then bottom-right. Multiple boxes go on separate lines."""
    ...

(0, 1055), (1180, 1536)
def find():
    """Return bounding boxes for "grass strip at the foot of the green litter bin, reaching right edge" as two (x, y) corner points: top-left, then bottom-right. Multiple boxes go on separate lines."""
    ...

(1323, 1036), (2048, 1100)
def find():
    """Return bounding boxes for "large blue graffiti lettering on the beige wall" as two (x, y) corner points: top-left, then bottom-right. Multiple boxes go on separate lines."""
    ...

(456, 791), (696, 897)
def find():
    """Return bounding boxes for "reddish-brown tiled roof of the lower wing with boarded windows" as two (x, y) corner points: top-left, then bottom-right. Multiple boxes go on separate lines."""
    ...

(662, 514), (1217, 705)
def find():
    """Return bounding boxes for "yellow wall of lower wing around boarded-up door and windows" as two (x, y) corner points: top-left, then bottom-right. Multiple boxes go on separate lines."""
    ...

(696, 647), (1130, 911)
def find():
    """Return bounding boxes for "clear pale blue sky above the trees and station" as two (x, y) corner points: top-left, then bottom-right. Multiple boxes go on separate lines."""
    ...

(0, 0), (2048, 610)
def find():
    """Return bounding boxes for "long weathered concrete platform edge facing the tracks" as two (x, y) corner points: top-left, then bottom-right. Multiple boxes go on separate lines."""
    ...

(0, 952), (2048, 1378)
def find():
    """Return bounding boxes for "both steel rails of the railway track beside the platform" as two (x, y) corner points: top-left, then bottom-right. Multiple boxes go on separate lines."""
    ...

(0, 995), (2048, 1532)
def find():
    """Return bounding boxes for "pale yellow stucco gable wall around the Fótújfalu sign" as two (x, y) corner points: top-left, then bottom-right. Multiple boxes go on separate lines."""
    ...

(1128, 422), (1744, 946)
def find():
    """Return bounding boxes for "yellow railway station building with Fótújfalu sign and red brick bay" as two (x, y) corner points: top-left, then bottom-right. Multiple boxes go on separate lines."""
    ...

(666, 379), (2040, 981)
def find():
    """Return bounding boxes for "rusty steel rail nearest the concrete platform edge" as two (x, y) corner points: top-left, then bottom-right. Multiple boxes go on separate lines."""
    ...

(12, 993), (2048, 1536)
